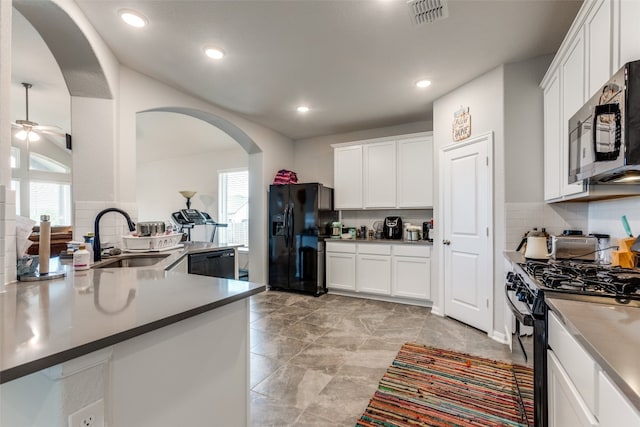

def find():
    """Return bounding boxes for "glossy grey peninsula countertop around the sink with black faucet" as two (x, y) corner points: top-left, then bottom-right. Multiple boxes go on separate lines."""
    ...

(0, 243), (265, 384)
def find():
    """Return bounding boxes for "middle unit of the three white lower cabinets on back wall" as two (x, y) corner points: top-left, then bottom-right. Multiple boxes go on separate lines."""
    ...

(356, 243), (391, 295)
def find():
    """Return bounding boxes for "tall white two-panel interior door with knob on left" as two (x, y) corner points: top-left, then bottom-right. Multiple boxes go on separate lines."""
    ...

(440, 134), (493, 332)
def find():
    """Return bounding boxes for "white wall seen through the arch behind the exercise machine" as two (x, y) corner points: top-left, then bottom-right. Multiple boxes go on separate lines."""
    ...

(136, 146), (249, 222)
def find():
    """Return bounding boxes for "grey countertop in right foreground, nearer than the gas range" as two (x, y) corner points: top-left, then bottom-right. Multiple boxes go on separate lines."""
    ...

(545, 298), (640, 411)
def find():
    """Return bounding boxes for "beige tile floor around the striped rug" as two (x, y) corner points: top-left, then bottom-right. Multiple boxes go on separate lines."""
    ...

(251, 291), (525, 427)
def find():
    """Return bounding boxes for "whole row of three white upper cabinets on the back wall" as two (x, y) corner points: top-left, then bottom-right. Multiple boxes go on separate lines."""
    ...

(333, 132), (433, 209)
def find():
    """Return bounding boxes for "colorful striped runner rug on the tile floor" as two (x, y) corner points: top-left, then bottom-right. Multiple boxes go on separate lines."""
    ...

(356, 343), (533, 427)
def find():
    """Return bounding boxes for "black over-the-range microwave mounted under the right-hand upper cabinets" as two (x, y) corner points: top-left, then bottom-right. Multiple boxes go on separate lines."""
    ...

(568, 61), (640, 184)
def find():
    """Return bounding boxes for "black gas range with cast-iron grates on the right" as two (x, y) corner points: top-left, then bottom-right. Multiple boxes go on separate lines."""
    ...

(505, 260), (640, 427)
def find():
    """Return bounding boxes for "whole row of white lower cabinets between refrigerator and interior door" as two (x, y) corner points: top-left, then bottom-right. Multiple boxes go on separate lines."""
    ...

(326, 242), (431, 301)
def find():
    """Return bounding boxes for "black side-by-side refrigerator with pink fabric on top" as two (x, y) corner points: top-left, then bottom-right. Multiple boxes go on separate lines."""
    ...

(269, 183), (338, 296)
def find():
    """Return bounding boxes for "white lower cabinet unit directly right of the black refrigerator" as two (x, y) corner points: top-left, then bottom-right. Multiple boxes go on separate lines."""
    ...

(326, 242), (356, 291)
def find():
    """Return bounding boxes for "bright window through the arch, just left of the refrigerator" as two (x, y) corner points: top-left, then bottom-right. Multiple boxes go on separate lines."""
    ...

(217, 169), (249, 246)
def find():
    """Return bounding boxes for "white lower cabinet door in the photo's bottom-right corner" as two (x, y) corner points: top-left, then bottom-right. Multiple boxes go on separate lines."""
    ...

(598, 372), (640, 427)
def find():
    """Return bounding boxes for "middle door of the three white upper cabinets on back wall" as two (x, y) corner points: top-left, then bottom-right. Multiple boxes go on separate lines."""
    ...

(362, 141), (396, 208)
